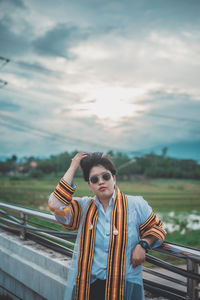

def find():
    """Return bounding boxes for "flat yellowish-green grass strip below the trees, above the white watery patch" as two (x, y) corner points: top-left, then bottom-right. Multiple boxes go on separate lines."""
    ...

(0, 176), (200, 212)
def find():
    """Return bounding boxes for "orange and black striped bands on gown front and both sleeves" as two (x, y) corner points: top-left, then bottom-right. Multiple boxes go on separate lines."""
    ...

(49, 179), (166, 300)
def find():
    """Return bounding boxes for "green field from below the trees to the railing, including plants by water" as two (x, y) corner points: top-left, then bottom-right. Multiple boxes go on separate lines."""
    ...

(0, 176), (200, 247)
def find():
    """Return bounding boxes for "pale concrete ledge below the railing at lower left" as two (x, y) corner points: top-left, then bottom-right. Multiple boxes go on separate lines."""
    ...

(0, 230), (70, 300)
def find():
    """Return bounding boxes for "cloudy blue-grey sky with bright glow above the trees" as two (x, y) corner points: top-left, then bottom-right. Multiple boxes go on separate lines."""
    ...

(0, 0), (200, 156)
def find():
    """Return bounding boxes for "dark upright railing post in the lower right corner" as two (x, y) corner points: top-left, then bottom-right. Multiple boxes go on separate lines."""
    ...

(187, 258), (200, 300)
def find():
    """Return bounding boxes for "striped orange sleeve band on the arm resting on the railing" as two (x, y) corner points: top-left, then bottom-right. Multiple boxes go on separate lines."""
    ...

(139, 213), (166, 242)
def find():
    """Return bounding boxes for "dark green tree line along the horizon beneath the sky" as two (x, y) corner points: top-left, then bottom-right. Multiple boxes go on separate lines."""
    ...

(0, 147), (200, 179)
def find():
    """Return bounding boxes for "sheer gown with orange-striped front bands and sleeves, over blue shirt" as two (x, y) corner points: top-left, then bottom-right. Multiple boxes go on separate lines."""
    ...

(49, 180), (165, 300)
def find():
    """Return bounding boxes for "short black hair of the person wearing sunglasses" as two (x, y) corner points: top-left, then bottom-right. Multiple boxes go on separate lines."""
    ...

(80, 152), (116, 181)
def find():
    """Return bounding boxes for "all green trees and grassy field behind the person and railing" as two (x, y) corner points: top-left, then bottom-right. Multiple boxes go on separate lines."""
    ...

(0, 148), (200, 248)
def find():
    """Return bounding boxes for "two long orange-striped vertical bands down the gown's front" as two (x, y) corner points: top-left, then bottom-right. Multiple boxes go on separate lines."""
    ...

(74, 188), (128, 300)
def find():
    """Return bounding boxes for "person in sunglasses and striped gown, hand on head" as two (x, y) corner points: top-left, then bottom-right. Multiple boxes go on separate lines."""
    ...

(48, 152), (166, 300)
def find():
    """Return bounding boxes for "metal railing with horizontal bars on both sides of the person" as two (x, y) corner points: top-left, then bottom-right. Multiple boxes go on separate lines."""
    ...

(0, 202), (200, 300)
